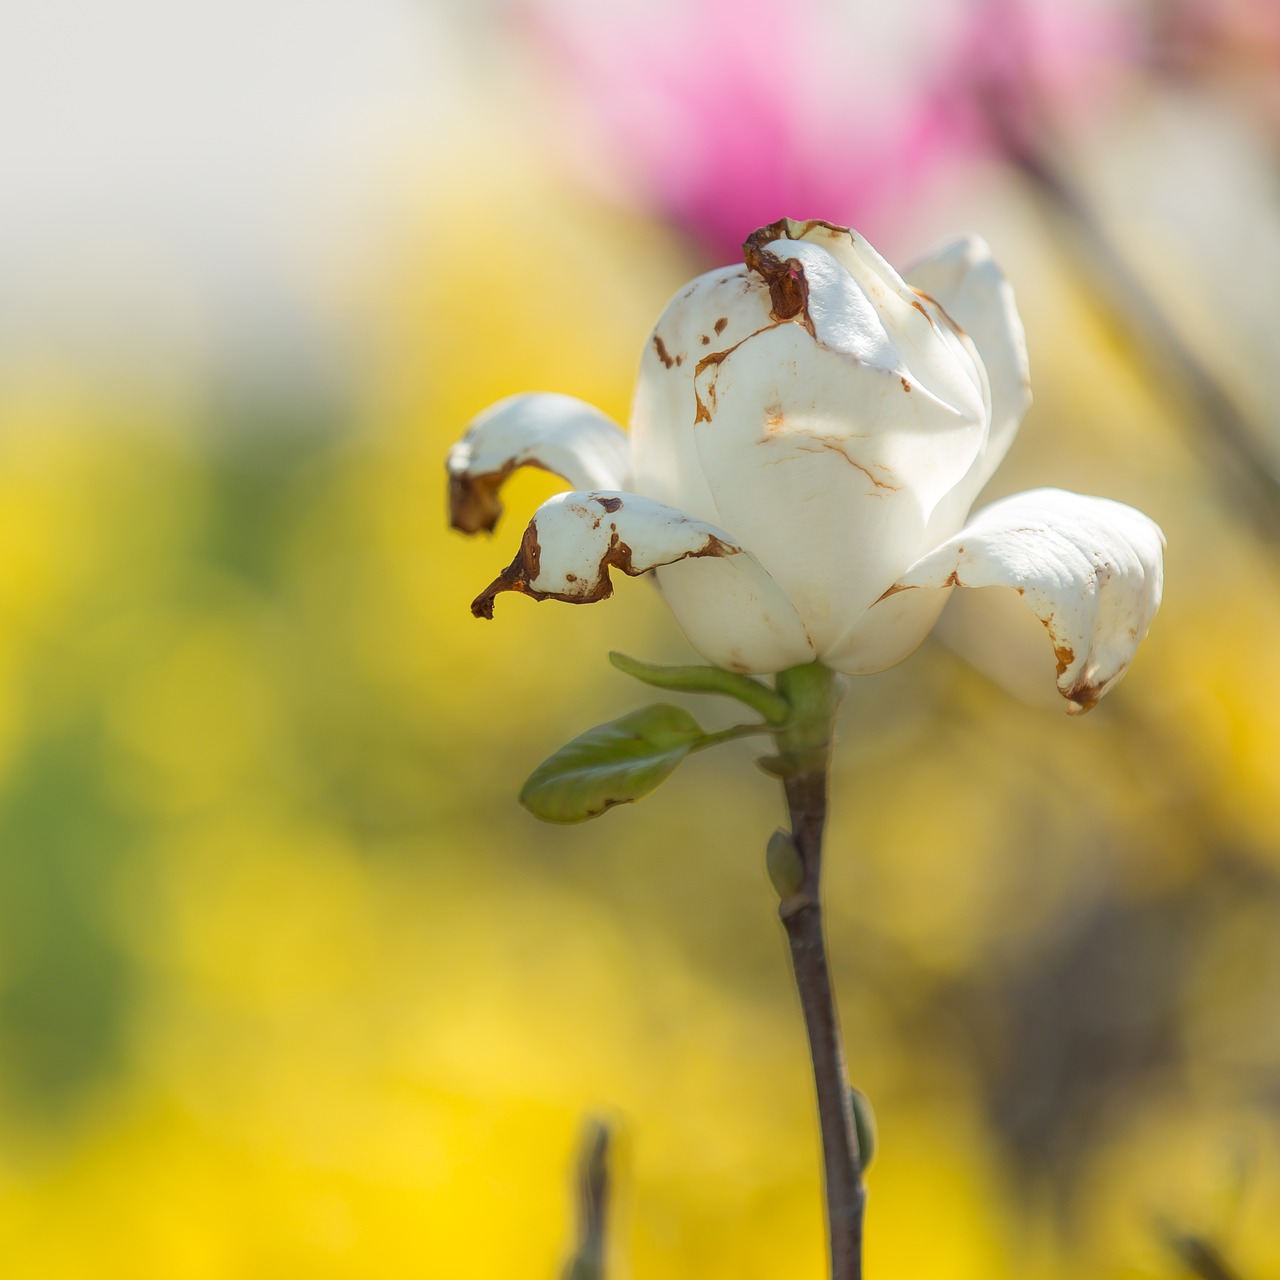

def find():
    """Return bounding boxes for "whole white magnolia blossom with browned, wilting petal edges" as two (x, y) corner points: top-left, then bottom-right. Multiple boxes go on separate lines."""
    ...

(448, 219), (1164, 712)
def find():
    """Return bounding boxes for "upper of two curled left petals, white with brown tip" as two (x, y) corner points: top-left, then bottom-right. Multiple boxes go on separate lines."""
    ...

(445, 392), (628, 534)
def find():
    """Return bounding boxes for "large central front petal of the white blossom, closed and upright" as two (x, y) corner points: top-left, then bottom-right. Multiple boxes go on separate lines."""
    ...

(692, 241), (987, 653)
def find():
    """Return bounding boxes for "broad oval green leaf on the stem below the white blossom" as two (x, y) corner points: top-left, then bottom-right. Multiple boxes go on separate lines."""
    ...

(520, 703), (707, 822)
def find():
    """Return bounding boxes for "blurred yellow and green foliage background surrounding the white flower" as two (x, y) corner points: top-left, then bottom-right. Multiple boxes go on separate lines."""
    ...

(0, 5), (1280, 1280)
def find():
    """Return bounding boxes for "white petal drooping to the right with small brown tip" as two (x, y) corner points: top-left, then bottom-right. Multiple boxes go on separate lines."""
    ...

(873, 489), (1165, 714)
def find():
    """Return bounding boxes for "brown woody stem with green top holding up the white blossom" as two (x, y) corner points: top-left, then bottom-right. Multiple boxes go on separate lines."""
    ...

(762, 663), (865, 1280)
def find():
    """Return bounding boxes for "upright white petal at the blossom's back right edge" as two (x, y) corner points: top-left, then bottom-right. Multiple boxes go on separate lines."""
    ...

(904, 236), (1032, 486)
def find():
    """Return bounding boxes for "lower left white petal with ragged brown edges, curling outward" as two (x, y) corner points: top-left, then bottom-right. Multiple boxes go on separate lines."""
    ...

(471, 492), (813, 672)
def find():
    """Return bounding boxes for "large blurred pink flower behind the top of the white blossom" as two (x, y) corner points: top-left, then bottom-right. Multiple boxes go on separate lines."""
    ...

(522, 0), (1133, 256)
